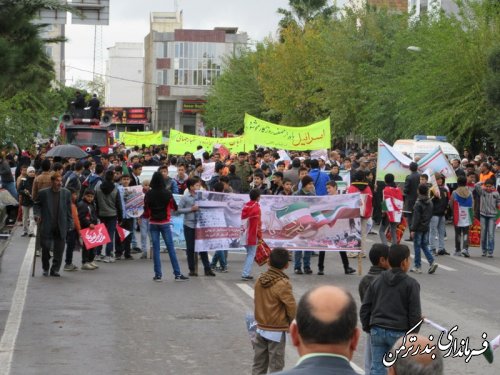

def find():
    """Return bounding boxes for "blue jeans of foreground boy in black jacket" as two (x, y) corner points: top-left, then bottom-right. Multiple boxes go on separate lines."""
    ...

(370, 326), (406, 375)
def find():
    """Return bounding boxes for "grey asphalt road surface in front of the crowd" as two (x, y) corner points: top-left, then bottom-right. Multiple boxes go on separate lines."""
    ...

(0, 227), (500, 375)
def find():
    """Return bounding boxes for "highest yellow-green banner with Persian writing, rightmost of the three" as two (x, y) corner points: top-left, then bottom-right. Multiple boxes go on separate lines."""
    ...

(245, 113), (331, 151)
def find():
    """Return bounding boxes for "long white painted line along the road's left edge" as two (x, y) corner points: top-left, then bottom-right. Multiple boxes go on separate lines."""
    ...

(0, 237), (35, 375)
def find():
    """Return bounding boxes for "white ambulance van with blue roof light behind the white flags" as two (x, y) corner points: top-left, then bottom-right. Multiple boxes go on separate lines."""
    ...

(393, 135), (460, 161)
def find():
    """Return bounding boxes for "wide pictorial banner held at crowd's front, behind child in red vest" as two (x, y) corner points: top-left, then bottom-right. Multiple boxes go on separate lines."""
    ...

(195, 191), (361, 252)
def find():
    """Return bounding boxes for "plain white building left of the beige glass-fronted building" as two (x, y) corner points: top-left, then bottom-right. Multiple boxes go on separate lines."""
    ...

(105, 43), (144, 107)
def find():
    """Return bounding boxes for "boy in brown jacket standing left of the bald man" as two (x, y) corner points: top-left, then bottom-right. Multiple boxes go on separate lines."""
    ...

(252, 247), (297, 375)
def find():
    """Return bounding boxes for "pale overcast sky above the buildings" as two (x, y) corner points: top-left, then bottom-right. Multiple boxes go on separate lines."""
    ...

(66, 0), (288, 85)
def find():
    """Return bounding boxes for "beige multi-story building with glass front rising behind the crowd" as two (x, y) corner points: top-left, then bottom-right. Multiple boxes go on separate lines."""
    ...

(144, 12), (248, 136)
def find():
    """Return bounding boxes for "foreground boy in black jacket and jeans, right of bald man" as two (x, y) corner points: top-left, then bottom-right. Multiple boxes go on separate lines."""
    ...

(359, 245), (422, 375)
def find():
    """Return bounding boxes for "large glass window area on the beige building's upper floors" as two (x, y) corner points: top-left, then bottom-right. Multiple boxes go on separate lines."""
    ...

(173, 42), (224, 86)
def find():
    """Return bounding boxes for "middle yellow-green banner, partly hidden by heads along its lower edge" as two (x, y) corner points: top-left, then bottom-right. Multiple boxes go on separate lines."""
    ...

(168, 129), (245, 155)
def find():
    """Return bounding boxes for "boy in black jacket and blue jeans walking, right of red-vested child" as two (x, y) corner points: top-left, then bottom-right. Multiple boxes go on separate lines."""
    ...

(410, 185), (438, 273)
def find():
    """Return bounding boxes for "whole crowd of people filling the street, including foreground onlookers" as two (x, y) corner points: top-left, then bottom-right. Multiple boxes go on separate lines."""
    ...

(0, 140), (500, 375)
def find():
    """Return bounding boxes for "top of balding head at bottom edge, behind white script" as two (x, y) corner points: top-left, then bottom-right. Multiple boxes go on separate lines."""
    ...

(388, 334), (444, 375)
